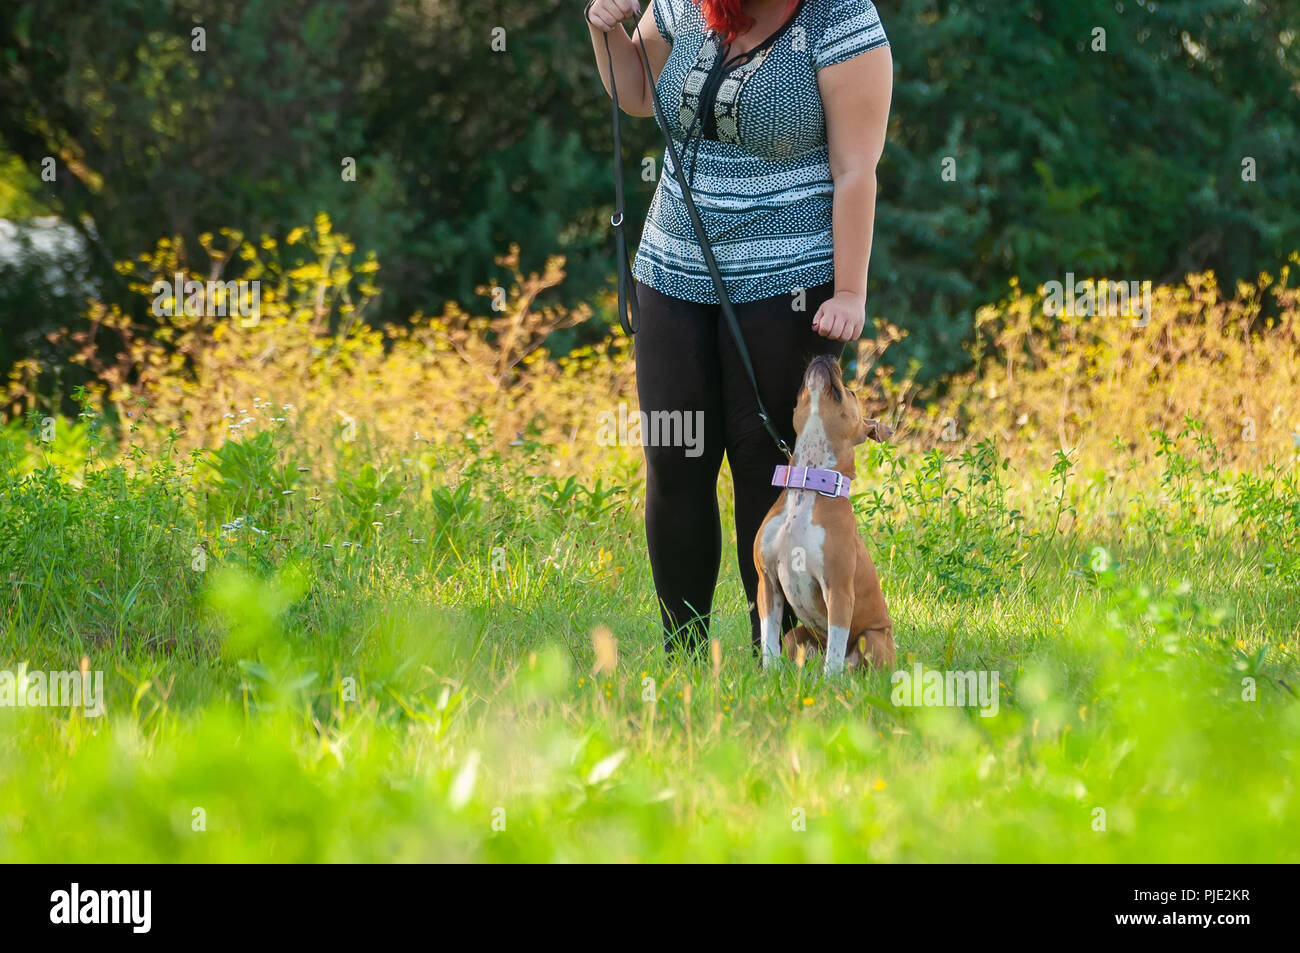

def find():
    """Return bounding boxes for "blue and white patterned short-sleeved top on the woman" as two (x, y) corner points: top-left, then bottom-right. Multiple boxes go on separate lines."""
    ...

(632, 0), (889, 303)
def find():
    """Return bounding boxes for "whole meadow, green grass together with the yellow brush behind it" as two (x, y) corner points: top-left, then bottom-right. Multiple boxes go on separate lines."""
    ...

(0, 228), (1300, 863)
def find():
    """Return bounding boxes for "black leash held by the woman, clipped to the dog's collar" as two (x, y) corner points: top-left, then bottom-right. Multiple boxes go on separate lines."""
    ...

(589, 13), (793, 459)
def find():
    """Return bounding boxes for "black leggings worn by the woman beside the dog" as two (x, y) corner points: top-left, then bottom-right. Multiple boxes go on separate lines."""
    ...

(636, 276), (844, 651)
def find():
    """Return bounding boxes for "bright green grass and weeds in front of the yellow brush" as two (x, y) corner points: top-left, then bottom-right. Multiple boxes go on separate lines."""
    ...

(0, 410), (1300, 862)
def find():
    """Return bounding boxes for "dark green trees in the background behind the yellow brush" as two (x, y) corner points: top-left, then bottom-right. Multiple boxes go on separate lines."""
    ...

(0, 0), (1300, 380)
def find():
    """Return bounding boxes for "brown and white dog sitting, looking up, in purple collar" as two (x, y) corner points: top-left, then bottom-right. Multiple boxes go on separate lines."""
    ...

(754, 356), (894, 673)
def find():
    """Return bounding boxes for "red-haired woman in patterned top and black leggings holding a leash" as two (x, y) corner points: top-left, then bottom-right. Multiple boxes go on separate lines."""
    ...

(586, 0), (893, 651)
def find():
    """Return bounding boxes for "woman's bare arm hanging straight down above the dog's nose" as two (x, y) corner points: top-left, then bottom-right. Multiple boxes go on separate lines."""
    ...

(813, 46), (893, 341)
